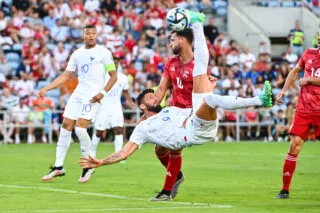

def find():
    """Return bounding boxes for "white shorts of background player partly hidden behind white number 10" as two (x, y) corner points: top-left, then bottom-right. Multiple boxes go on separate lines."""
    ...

(94, 105), (124, 131)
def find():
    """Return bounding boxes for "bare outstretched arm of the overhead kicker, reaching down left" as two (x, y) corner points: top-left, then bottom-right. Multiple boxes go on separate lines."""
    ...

(79, 141), (139, 168)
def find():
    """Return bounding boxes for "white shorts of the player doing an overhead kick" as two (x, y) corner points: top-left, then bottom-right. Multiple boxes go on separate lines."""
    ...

(185, 114), (219, 146)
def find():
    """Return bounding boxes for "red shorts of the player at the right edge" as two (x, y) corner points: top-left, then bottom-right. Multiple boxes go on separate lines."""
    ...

(289, 112), (320, 140)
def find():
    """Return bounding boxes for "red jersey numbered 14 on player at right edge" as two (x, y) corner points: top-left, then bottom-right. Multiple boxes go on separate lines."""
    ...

(297, 48), (320, 113)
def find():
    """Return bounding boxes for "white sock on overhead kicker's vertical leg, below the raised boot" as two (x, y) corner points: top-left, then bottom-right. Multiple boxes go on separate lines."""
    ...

(192, 22), (209, 77)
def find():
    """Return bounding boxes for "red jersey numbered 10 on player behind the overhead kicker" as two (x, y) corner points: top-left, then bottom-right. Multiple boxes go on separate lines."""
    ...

(163, 56), (194, 108)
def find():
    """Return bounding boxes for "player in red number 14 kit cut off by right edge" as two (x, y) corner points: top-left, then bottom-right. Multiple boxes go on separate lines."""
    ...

(275, 33), (320, 199)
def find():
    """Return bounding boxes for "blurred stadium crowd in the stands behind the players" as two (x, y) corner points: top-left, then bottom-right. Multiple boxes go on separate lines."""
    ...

(0, 0), (314, 143)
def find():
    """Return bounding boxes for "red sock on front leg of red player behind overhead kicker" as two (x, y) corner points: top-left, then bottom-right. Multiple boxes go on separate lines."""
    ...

(163, 153), (182, 191)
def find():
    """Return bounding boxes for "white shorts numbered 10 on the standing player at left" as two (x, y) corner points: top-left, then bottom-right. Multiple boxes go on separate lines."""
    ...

(63, 93), (101, 120)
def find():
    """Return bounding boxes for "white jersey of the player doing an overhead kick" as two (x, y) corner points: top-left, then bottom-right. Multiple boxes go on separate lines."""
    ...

(130, 107), (191, 150)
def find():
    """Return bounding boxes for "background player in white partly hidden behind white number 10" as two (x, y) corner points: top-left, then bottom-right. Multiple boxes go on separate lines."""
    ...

(88, 52), (136, 179)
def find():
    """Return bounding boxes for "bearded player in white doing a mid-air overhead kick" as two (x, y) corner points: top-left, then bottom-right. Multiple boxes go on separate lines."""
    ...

(79, 12), (272, 201)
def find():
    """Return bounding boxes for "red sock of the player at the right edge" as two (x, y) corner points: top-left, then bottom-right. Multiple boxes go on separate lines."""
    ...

(282, 153), (298, 191)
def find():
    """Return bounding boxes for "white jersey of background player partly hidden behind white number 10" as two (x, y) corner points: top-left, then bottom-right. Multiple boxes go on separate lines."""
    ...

(100, 70), (129, 110)
